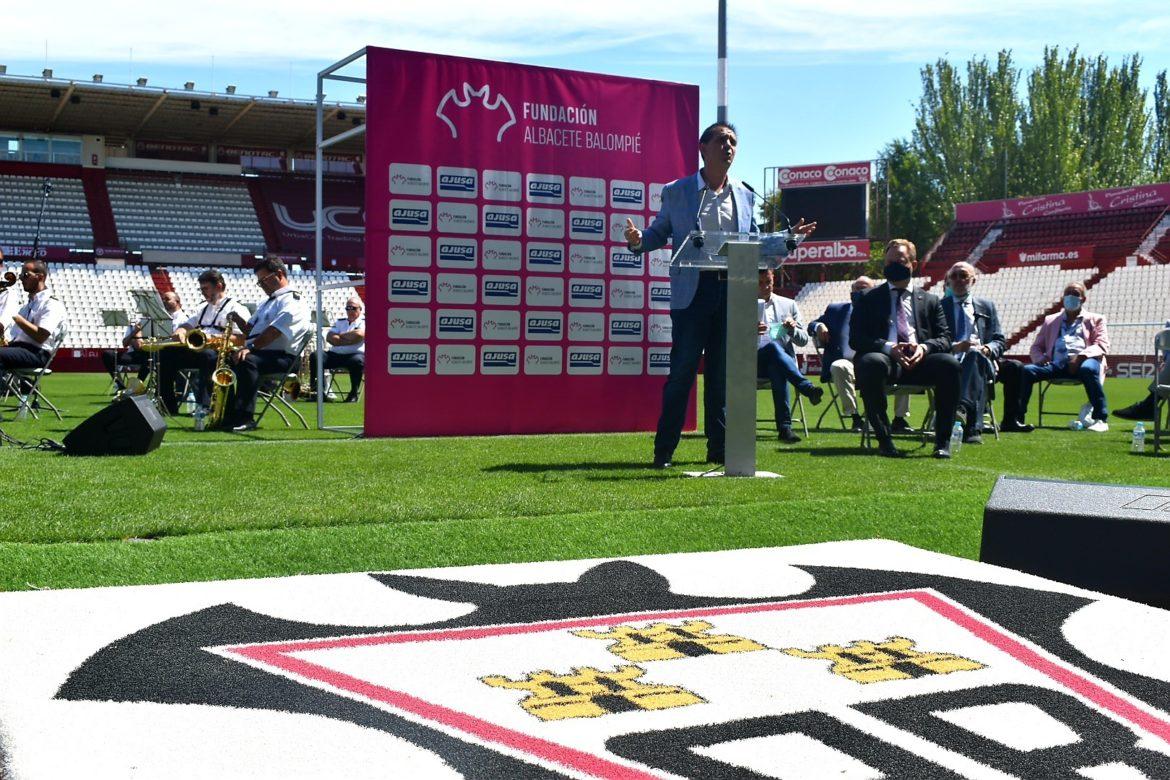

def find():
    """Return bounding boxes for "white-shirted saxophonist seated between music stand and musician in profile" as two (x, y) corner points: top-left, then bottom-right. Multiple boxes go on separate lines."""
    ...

(158, 268), (249, 414)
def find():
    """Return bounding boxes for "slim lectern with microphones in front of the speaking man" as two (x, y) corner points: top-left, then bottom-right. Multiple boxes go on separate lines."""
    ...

(670, 230), (794, 477)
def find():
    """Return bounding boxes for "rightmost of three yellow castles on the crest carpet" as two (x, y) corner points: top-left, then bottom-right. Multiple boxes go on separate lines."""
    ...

(784, 636), (984, 683)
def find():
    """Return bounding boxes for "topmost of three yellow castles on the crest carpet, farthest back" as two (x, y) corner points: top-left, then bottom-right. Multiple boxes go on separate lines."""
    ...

(572, 620), (768, 663)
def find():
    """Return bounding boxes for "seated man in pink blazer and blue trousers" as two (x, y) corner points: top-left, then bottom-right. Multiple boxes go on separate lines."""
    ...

(1019, 282), (1109, 433)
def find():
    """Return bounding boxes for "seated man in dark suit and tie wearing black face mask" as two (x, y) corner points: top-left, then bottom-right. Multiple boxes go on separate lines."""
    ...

(849, 239), (959, 458)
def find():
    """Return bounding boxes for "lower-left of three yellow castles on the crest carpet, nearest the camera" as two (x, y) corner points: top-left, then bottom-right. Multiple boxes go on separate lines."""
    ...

(481, 667), (704, 720)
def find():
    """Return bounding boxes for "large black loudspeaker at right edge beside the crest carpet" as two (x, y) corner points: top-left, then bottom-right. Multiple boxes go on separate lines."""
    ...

(979, 477), (1170, 608)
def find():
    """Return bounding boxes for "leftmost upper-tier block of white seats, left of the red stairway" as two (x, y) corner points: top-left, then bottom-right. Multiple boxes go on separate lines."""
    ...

(0, 174), (94, 248)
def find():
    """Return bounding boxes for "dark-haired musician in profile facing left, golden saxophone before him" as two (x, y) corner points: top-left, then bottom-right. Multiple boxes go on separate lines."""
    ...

(226, 256), (310, 433)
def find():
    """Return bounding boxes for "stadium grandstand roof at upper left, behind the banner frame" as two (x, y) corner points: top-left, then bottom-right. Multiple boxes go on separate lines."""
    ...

(0, 75), (366, 154)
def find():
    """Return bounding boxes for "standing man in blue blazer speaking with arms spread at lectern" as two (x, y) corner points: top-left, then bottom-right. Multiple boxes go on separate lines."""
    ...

(626, 122), (817, 469)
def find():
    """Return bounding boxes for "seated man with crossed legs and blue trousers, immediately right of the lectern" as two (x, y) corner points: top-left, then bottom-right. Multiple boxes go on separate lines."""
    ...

(756, 269), (825, 444)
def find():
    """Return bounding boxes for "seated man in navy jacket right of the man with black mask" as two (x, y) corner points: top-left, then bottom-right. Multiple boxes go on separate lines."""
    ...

(943, 262), (1006, 444)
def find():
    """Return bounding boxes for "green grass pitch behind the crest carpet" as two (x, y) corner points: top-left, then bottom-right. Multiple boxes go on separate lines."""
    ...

(0, 374), (1170, 589)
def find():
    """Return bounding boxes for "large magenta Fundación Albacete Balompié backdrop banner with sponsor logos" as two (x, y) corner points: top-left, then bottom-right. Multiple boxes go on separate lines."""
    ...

(365, 48), (698, 436)
